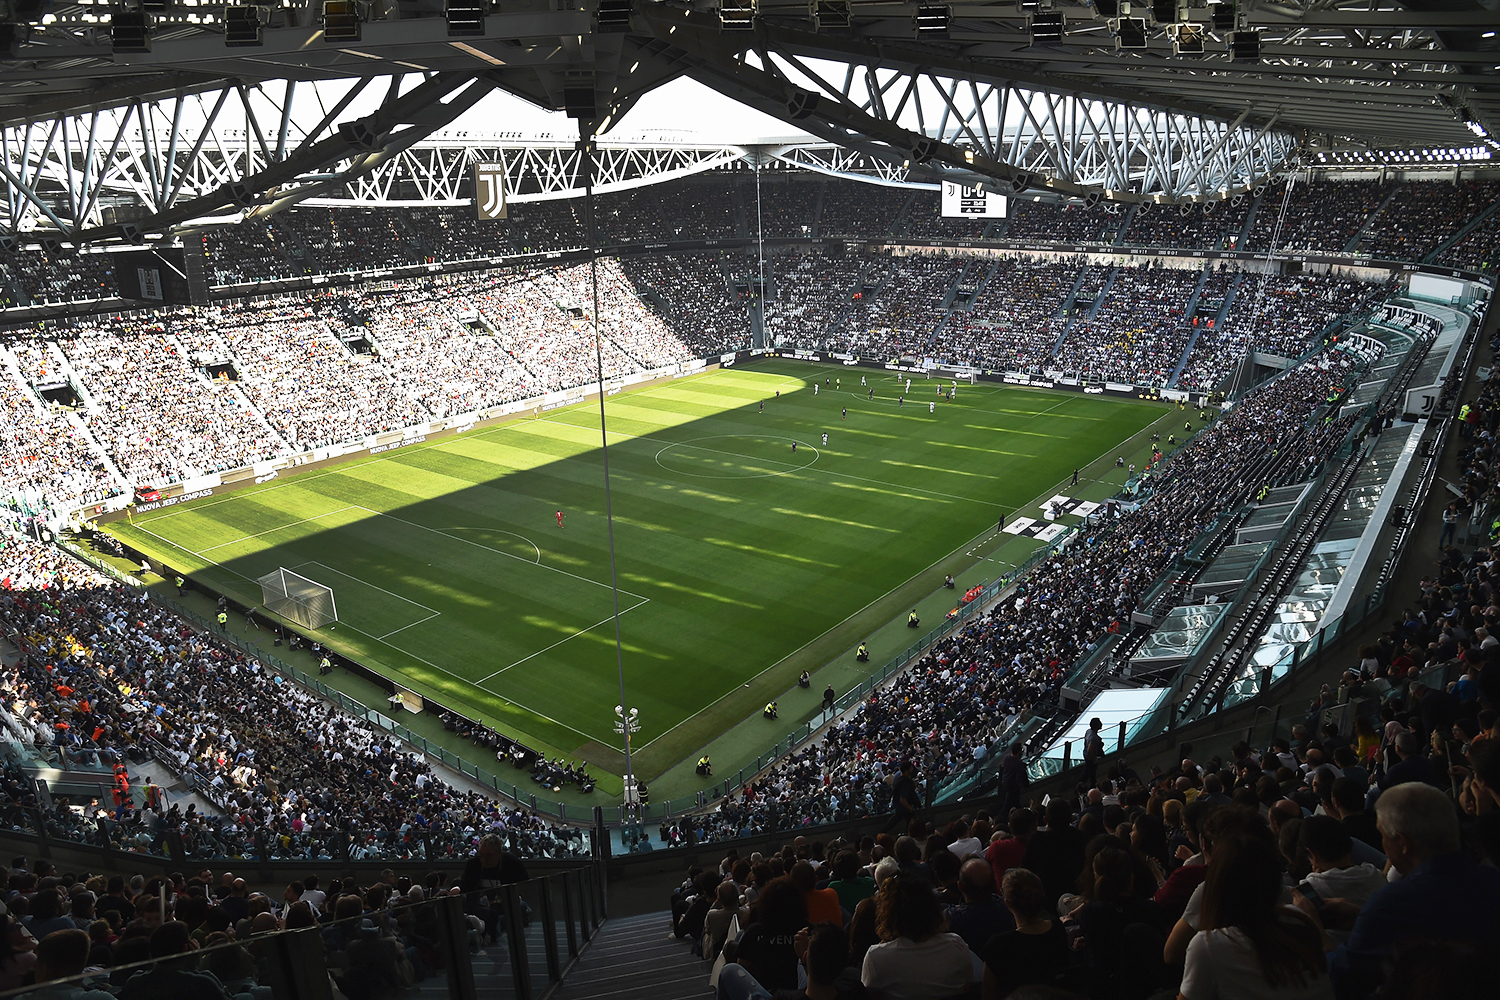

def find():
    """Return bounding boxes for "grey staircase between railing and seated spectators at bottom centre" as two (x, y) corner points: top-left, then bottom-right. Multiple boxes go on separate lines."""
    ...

(552, 910), (711, 1000)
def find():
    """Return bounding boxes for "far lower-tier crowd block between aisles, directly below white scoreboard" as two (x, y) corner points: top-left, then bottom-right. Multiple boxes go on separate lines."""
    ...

(935, 256), (1086, 372)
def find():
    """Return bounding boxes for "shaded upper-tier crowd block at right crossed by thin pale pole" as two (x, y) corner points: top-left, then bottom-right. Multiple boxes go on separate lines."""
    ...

(1245, 178), (1392, 253)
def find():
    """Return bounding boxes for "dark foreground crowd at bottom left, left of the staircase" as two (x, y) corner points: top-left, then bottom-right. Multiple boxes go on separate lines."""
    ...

(0, 837), (558, 1000)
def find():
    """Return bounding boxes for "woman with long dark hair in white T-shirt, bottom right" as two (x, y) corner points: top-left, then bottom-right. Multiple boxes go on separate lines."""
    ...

(1181, 837), (1334, 1000)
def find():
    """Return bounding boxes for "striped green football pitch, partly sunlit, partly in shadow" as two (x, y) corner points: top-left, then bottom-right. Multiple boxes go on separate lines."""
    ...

(111, 361), (1164, 780)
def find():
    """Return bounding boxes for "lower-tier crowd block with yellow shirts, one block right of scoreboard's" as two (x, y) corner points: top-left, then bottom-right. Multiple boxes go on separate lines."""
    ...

(1053, 267), (1203, 385)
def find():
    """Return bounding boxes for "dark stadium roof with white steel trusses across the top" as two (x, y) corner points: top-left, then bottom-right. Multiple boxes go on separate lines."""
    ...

(0, 0), (1500, 238)
